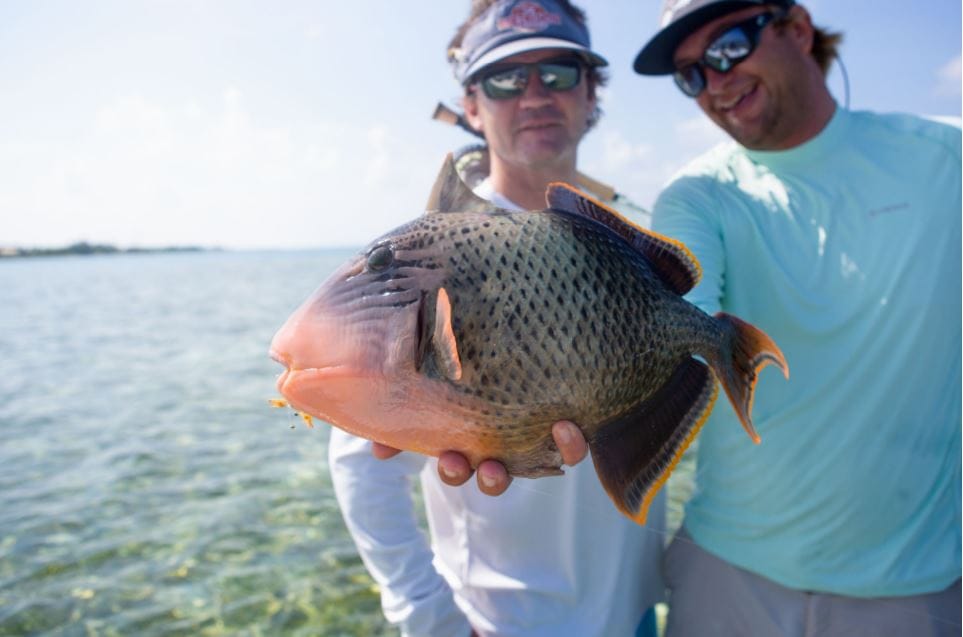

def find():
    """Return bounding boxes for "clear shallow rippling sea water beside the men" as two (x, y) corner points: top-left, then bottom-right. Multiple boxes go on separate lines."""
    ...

(0, 251), (688, 637)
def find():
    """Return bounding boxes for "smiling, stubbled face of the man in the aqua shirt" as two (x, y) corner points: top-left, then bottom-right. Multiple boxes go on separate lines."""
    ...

(674, 5), (834, 150)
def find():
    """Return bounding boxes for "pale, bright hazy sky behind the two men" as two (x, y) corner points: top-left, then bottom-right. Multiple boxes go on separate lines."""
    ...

(0, 0), (961, 249)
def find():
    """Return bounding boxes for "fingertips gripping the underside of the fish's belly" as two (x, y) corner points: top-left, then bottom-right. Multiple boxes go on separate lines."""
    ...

(371, 420), (588, 496)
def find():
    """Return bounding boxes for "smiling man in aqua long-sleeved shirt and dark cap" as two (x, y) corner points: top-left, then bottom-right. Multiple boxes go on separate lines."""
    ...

(635, 0), (961, 636)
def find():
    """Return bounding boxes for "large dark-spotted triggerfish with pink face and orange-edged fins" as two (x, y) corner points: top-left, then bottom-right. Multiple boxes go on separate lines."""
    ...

(271, 156), (788, 523)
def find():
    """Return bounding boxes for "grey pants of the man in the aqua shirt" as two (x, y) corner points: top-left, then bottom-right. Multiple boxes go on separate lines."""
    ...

(663, 529), (961, 637)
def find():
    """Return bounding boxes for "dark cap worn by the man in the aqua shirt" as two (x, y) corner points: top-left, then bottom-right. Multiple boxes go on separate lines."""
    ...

(632, 0), (796, 75)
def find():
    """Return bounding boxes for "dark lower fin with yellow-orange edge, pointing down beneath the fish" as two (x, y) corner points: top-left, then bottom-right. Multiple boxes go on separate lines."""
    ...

(589, 358), (718, 524)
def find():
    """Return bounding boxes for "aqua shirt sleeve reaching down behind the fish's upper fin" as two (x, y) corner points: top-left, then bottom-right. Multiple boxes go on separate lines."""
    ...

(652, 177), (726, 314)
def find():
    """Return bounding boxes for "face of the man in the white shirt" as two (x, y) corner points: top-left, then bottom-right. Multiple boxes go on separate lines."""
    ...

(464, 49), (595, 170)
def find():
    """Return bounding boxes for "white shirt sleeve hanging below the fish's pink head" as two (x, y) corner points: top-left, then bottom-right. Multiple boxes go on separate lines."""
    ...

(328, 428), (471, 637)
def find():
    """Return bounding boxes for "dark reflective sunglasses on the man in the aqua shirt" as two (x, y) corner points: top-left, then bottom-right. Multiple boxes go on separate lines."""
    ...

(672, 12), (785, 97)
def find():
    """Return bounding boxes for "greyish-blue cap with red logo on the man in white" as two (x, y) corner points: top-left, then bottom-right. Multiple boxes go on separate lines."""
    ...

(448, 0), (608, 84)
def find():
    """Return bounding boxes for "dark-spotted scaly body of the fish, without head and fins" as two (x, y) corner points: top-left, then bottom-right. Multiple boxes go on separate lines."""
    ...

(394, 211), (692, 439)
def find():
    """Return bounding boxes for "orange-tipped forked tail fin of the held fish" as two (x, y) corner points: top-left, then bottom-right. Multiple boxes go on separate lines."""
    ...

(709, 312), (789, 444)
